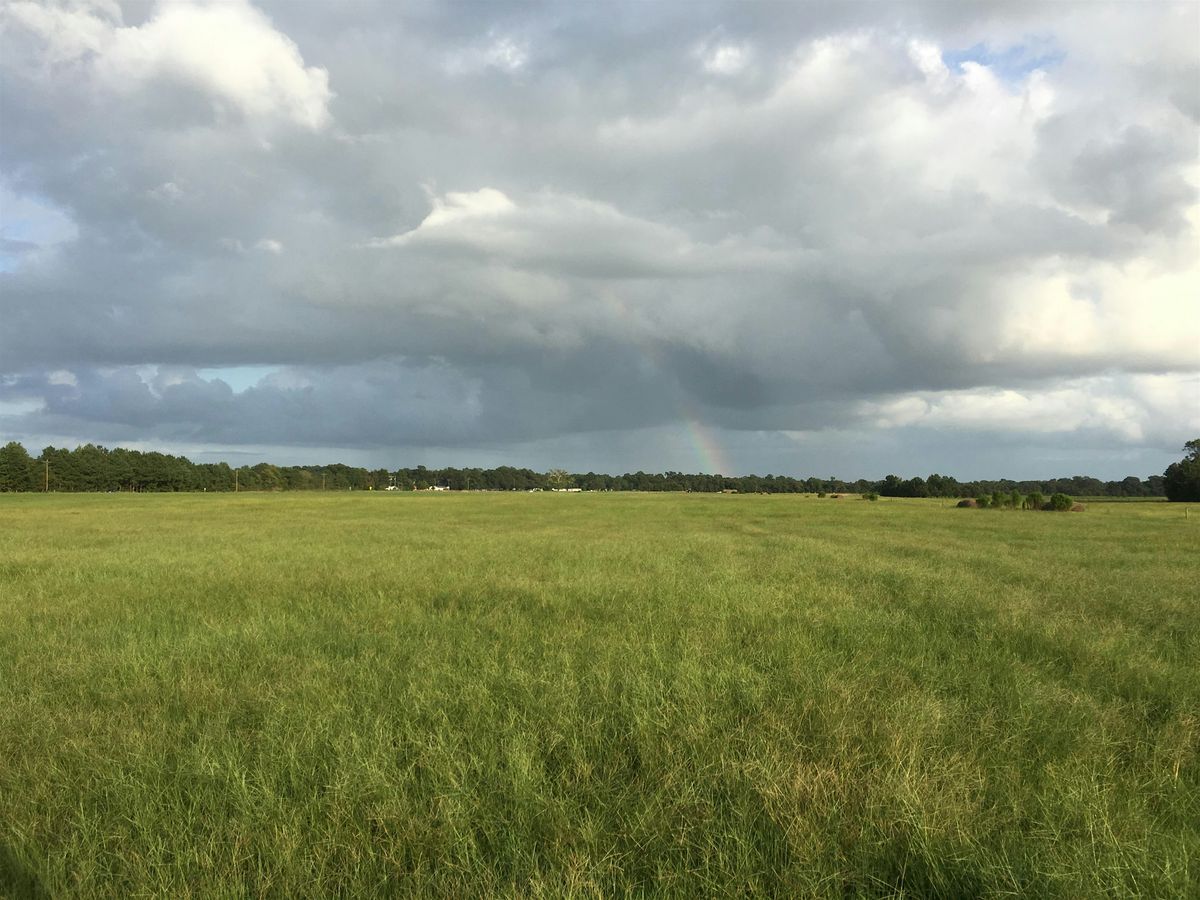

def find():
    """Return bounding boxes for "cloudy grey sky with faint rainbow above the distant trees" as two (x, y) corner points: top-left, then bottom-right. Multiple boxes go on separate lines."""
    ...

(0, 0), (1200, 479)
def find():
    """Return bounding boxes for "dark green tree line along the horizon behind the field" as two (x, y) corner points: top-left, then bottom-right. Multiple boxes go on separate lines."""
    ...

(0, 442), (1200, 499)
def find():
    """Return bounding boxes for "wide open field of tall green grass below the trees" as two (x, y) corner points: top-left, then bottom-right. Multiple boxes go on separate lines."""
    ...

(0, 494), (1200, 898)
